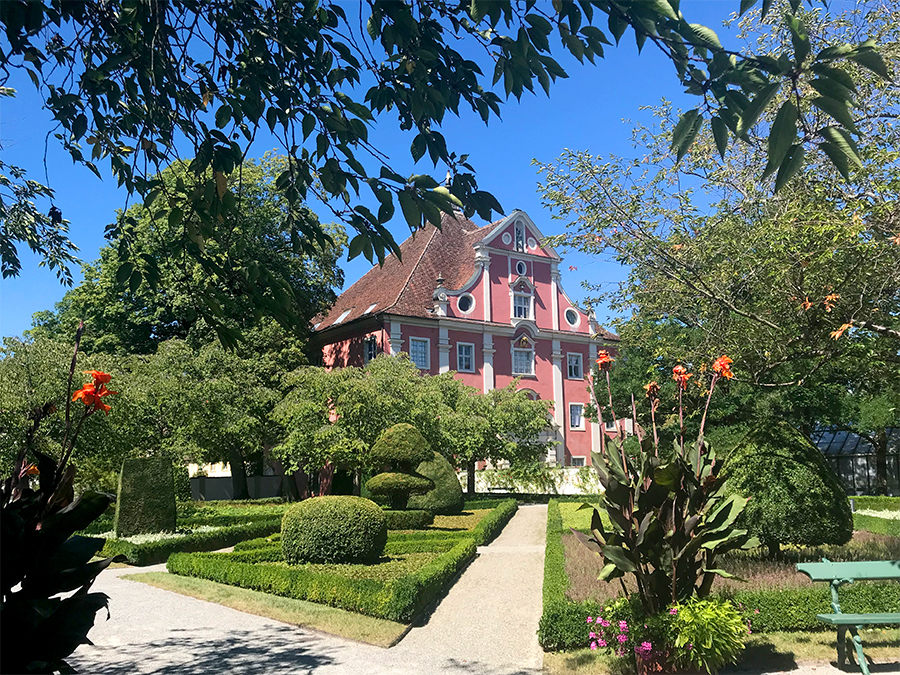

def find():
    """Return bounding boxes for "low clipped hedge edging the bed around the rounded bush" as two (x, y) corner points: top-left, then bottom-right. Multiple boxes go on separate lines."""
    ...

(167, 499), (518, 623)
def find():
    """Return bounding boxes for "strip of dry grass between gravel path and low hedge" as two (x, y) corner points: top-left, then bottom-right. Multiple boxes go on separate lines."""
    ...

(122, 572), (407, 647)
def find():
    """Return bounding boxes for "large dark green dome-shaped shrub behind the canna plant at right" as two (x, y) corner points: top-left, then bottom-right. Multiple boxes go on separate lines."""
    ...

(724, 423), (853, 556)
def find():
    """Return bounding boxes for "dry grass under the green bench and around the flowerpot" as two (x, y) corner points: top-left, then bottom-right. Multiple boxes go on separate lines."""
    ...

(544, 628), (900, 675)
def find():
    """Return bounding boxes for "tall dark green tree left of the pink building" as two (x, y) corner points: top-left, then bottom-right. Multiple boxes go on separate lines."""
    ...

(33, 154), (346, 352)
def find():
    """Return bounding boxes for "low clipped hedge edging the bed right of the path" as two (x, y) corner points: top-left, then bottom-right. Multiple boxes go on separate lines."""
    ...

(538, 500), (900, 651)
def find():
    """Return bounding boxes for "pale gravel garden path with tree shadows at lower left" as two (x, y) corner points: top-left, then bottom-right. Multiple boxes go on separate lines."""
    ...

(71, 505), (547, 675)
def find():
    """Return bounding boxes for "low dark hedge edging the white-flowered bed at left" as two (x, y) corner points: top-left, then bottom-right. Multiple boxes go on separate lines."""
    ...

(99, 517), (281, 567)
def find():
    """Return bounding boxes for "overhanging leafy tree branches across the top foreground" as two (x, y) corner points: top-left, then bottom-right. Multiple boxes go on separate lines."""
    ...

(0, 0), (888, 342)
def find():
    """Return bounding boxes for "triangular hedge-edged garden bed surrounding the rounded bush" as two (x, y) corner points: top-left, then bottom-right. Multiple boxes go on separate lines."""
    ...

(158, 500), (517, 623)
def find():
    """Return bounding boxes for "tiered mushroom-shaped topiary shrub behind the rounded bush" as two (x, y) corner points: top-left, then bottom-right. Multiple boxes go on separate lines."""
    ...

(366, 424), (434, 511)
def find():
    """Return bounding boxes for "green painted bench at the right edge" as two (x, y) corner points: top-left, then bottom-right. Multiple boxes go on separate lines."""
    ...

(797, 558), (900, 675)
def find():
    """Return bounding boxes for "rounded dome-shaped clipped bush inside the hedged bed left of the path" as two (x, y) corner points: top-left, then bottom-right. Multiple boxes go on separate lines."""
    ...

(281, 495), (387, 565)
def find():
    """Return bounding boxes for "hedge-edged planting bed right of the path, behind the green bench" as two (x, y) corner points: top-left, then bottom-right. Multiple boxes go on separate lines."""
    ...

(538, 501), (900, 656)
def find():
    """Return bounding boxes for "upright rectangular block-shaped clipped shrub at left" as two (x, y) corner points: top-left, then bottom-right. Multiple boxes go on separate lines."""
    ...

(115, 457), (176, 539)
